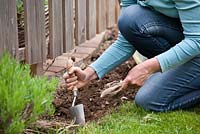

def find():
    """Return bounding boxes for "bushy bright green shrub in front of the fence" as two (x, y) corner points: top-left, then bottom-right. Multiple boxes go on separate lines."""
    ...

(0, 54), (58, 134)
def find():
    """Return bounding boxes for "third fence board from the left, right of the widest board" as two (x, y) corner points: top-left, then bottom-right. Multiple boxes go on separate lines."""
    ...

(48, 0), (63, 58)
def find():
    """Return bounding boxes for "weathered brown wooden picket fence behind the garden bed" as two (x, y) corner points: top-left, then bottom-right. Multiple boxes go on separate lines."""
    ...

(0, 0), (120, 73)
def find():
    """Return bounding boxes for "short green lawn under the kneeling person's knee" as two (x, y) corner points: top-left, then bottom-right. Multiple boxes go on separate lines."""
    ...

(77, 102), (200, 134)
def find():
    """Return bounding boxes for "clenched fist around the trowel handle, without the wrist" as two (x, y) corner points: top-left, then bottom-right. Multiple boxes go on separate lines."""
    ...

(63, 67), (88, 90)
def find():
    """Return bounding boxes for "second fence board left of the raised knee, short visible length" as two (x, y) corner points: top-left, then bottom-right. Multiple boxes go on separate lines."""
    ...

(106, 0), (116, 27)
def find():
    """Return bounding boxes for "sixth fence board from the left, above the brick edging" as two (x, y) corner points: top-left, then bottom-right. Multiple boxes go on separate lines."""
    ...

(86, 0), (96, 40)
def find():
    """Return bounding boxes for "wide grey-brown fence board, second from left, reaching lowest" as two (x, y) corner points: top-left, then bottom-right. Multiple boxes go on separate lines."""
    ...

(24, 0), (46, 65)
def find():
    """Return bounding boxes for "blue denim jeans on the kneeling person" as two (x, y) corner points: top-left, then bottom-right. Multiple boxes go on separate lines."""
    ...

(119, 5), (200, 112)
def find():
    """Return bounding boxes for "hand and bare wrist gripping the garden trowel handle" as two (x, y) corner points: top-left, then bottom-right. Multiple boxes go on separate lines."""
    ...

(63, 67), (97, 90)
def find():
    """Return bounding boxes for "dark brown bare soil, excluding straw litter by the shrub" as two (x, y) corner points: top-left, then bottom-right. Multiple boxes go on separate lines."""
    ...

(53, 28), (136, 121)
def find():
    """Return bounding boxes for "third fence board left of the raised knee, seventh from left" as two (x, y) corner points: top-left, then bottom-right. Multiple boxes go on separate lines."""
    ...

(96, 0), (107, 33)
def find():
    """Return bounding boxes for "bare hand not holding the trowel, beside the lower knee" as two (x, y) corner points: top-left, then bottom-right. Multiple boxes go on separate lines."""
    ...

(122, 58), (160, 89)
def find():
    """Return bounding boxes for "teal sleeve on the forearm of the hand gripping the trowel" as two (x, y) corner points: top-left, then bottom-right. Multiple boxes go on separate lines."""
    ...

(90, 33), (135, 78)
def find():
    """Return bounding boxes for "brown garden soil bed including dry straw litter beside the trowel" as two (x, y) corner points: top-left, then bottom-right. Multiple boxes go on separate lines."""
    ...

(28, 27), (137, 134)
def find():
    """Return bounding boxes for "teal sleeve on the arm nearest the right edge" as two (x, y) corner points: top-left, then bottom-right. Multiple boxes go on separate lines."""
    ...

(157, 0), (200, 72)
